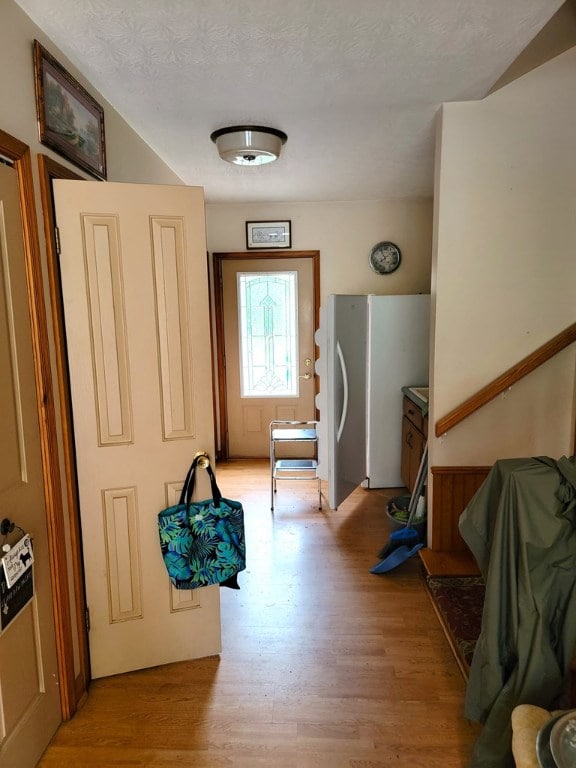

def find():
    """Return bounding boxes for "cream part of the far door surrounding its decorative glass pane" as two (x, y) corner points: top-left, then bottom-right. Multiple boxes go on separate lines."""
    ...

(222, 258), (315, 458)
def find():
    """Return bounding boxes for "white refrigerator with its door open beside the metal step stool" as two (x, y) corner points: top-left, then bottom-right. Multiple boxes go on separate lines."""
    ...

(316, 294), (430, 509)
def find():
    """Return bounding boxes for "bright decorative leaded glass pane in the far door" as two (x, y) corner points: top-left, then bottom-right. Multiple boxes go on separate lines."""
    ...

(238, 272), (298, 397)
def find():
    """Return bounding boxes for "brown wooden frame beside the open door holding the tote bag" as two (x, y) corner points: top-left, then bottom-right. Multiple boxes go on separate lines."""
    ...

(38, 155), (90, 720)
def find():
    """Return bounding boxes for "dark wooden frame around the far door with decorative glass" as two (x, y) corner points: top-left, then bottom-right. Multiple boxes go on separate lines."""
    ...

(212, 250), (320, 459)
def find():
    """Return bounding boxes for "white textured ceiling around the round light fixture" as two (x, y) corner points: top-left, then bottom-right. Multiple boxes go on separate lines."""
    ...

(17, 0), (562, 202)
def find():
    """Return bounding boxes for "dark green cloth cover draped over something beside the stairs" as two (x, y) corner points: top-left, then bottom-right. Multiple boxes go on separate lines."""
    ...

(460, 457), (576, 768)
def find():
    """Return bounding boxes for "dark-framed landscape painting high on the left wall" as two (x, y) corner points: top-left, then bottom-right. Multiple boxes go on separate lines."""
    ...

(34, 40), (106, 179)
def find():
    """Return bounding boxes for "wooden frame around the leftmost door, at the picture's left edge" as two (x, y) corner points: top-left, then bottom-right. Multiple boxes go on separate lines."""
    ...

(0, 134), (81, 719)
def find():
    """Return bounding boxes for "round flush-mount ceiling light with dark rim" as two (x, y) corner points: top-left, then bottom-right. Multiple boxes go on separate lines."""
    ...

(210, 125), (288, 165)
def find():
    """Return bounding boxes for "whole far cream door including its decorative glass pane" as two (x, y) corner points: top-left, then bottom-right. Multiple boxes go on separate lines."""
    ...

(216, 252), (318, 458)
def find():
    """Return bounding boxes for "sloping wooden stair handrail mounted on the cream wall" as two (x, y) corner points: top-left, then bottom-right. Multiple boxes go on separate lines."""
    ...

(434, 323), (576, 437)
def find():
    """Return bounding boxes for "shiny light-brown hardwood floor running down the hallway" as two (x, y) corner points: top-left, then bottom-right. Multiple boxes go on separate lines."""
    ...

(40, 461), (478, 768)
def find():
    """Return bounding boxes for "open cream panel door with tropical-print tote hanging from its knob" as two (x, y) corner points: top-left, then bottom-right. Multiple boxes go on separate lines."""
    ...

(54, 180), (220, 677)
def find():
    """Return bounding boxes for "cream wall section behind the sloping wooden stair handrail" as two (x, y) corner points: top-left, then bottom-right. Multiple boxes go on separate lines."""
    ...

(430, 48), (576, 472)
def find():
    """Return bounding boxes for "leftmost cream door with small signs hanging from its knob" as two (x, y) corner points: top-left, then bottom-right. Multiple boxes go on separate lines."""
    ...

(0, 165), (61, 768)
